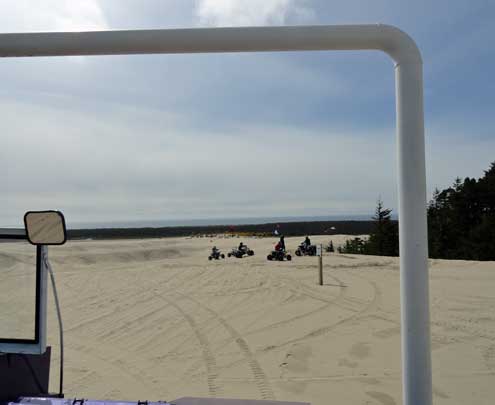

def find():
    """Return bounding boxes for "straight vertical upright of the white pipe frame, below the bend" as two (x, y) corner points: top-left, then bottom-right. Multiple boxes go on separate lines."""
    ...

(396, 63), (432, 405)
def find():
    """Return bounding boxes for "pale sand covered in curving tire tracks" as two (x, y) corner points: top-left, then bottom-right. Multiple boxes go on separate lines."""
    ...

(0, 236), (495, 405)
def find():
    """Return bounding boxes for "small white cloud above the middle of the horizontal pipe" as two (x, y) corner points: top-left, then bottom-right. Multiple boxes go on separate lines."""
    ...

(196, 0), (314, 26)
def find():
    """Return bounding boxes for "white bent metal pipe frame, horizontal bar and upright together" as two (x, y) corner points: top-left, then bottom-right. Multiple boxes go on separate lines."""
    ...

(0, 24), (431, 405)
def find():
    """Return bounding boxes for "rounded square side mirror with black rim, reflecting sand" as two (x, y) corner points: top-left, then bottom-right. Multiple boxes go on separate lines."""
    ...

(24, 211), (67, 245)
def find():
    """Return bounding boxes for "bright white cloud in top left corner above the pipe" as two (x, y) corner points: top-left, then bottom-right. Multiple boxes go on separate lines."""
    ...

(0, 0), (107, 32)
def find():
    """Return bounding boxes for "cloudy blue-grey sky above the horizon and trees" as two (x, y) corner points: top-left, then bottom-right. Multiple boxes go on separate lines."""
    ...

(0, 0), (495, 226)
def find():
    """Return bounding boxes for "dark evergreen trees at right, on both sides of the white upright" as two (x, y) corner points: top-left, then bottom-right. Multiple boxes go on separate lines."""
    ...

(339, 162), (495, 260)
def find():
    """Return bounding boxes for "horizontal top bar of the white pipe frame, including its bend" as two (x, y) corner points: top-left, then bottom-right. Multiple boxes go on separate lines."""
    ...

(0, 24), (421, 63)
